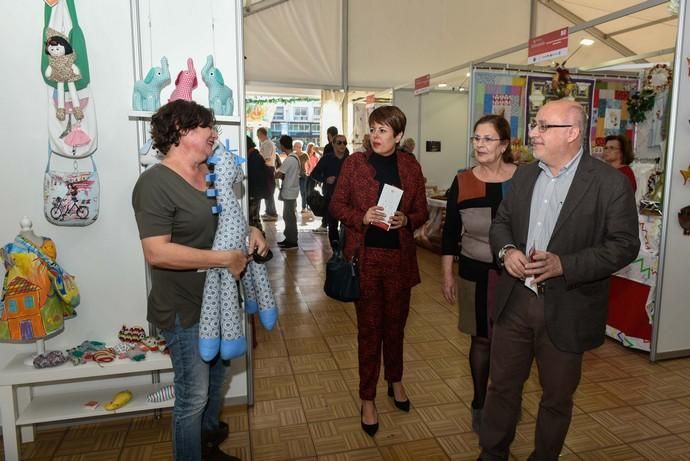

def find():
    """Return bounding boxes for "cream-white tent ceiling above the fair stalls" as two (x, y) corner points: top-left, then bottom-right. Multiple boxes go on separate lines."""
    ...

(244, 0), (678, 88)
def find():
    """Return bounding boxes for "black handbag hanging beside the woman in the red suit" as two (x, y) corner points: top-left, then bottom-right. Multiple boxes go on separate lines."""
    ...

(323, 226), (359, 303)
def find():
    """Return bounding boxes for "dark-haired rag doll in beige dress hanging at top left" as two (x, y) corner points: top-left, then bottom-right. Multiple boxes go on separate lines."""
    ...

(45, 28), (84, 120)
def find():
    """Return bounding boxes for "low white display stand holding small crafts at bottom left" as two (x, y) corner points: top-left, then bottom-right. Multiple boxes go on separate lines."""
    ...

(0, 352), (174, 460)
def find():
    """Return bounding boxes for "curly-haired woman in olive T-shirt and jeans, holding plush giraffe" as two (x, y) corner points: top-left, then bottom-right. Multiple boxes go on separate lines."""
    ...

(132, 100), (268, 461)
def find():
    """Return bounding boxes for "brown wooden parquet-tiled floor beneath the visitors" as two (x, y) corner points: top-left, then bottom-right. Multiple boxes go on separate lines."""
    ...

(0, 217), (690, 461)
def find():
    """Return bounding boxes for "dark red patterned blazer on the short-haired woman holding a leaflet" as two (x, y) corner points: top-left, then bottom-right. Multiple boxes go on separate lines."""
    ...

(329, 150), (429, 287)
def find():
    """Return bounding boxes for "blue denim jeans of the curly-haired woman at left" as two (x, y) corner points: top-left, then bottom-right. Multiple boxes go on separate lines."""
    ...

(161, 323), (228, 461)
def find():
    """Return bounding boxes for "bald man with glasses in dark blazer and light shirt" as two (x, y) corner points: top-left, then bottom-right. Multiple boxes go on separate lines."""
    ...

(479, 100), (640, 461)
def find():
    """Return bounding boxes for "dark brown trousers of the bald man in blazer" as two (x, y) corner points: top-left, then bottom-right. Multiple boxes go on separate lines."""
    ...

(479, 285), (582, 461)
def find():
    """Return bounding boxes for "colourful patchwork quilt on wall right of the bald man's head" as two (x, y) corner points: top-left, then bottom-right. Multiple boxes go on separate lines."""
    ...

(590, 79), (638, 156)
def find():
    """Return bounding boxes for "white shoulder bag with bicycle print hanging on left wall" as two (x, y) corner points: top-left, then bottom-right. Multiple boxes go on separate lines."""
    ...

(43, 150), (100, 226)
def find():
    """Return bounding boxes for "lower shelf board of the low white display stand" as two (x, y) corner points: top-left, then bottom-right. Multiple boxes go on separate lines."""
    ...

(16, 384), (175, 426)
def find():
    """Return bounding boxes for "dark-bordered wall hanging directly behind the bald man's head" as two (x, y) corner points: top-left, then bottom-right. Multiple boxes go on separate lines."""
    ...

(523, 75), (594, 145)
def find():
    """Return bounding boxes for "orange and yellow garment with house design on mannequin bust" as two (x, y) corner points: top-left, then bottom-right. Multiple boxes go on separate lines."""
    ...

(0, 219), (79, 341)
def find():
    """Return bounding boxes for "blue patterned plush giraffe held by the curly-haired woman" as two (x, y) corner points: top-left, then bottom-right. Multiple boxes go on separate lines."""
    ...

(199, 142), (278, 361)
